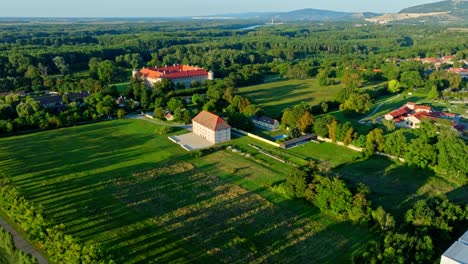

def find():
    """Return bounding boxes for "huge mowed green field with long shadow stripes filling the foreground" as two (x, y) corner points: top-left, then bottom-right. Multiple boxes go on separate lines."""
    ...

(0, 120), (372, 263)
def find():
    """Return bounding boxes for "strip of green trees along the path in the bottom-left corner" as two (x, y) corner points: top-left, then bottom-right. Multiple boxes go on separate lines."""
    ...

(0, 178), (113, 263)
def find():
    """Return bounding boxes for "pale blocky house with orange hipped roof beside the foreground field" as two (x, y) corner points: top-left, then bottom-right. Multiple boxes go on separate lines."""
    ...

(192, 111), (231, 144)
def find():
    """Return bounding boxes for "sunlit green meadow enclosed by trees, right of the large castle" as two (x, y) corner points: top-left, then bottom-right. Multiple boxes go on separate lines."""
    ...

(238, 79), (342, 117)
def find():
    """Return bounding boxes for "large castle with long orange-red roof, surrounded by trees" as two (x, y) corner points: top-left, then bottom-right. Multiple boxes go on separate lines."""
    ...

(132, 64), (214, 87)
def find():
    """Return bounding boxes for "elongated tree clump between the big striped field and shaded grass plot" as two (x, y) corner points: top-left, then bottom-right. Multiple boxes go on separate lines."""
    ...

(274, 161), (396, 230)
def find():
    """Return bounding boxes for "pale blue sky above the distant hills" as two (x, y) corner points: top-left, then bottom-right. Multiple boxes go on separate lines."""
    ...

(0, 0), (438, 17)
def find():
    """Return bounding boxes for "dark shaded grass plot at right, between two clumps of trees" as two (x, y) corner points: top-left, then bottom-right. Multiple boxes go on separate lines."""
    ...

(337, 156), (434, 217)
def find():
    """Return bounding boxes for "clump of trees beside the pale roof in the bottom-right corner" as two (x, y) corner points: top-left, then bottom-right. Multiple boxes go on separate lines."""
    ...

(354, 197), (468, 263)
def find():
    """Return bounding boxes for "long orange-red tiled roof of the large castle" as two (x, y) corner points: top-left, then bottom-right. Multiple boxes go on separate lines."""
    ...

(140, 65), (208, 79)
